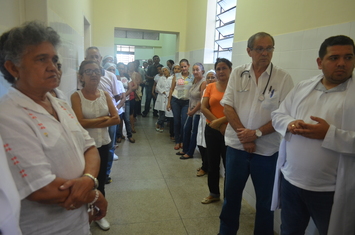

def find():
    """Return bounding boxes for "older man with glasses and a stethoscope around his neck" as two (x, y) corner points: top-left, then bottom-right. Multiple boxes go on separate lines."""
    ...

(219, 32), (293, 235)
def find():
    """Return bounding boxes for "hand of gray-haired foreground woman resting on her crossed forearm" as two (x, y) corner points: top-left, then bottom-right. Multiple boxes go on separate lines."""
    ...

(59, 176), (94, 210)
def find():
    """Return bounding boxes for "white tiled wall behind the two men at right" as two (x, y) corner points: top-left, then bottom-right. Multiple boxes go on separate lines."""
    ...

(232, 21), (355, 235)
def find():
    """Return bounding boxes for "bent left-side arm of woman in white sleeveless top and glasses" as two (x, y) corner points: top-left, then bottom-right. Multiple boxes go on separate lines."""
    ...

(70, 92), (109, 128)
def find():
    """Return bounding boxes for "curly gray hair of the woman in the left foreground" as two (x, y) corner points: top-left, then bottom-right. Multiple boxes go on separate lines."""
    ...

(0, 21), (60, 84)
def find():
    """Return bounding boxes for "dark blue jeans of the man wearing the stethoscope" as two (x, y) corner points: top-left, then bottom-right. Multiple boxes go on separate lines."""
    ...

(219, 146), (278, 235)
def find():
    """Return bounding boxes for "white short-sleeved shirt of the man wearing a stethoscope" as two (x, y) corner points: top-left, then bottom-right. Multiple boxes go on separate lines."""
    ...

(221, 63), (293, 156)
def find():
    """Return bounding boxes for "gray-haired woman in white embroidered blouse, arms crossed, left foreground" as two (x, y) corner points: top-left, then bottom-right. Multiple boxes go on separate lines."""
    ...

(0, 22), (107, 235)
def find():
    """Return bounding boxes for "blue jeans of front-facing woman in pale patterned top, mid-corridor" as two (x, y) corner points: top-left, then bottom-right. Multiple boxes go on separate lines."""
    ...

(171, 97), (189, 144)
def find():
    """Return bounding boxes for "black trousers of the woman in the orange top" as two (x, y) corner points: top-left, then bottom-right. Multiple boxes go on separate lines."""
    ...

(205, 125), (226, 197)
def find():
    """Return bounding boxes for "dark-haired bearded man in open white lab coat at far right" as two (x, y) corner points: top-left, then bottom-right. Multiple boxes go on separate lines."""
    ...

(272, 35), (355, 235)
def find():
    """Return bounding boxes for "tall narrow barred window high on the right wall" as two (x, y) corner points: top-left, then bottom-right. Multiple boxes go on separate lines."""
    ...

(214, 0), (237, 60)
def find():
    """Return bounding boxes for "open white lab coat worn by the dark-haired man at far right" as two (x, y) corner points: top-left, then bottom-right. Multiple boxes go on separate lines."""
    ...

(271, 74), (355, 235)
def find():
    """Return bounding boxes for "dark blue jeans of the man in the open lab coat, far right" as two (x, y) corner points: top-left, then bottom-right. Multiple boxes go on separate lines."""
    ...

(281, 177), (334, 235)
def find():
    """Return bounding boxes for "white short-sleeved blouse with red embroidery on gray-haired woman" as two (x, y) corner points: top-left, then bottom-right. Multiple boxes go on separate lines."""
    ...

(0, 88), (95, 235)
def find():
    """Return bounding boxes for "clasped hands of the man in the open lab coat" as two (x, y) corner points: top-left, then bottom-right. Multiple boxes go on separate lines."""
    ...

(293, 116), (330, 139)
